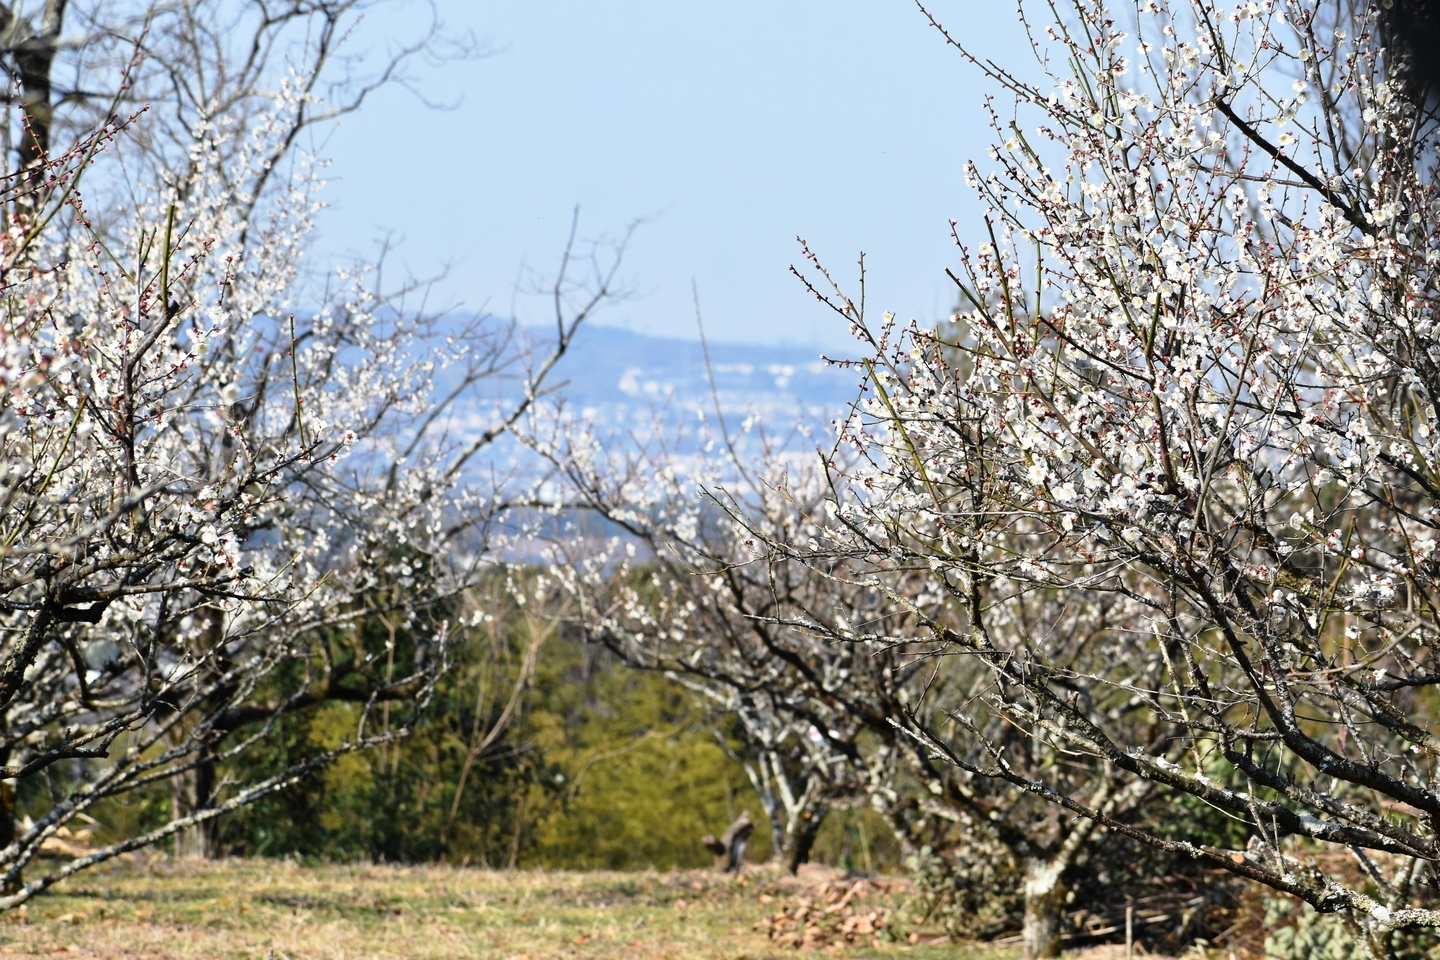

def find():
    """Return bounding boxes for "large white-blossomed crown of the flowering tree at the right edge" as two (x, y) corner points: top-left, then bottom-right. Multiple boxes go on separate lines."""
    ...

(769, 0), (1440, 931)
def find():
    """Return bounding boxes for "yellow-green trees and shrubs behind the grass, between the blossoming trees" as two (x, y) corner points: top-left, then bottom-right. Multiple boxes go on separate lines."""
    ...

(70, 570), (900, 869)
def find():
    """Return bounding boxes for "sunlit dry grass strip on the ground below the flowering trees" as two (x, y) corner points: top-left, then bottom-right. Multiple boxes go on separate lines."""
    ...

(0, 861), (1012, 960)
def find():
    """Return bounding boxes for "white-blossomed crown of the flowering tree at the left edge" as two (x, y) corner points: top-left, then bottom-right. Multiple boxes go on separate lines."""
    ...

(0, 54), (553, 907)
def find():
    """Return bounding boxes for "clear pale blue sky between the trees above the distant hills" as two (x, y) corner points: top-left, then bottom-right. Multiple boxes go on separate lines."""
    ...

(320, 0), (1027, 344)
